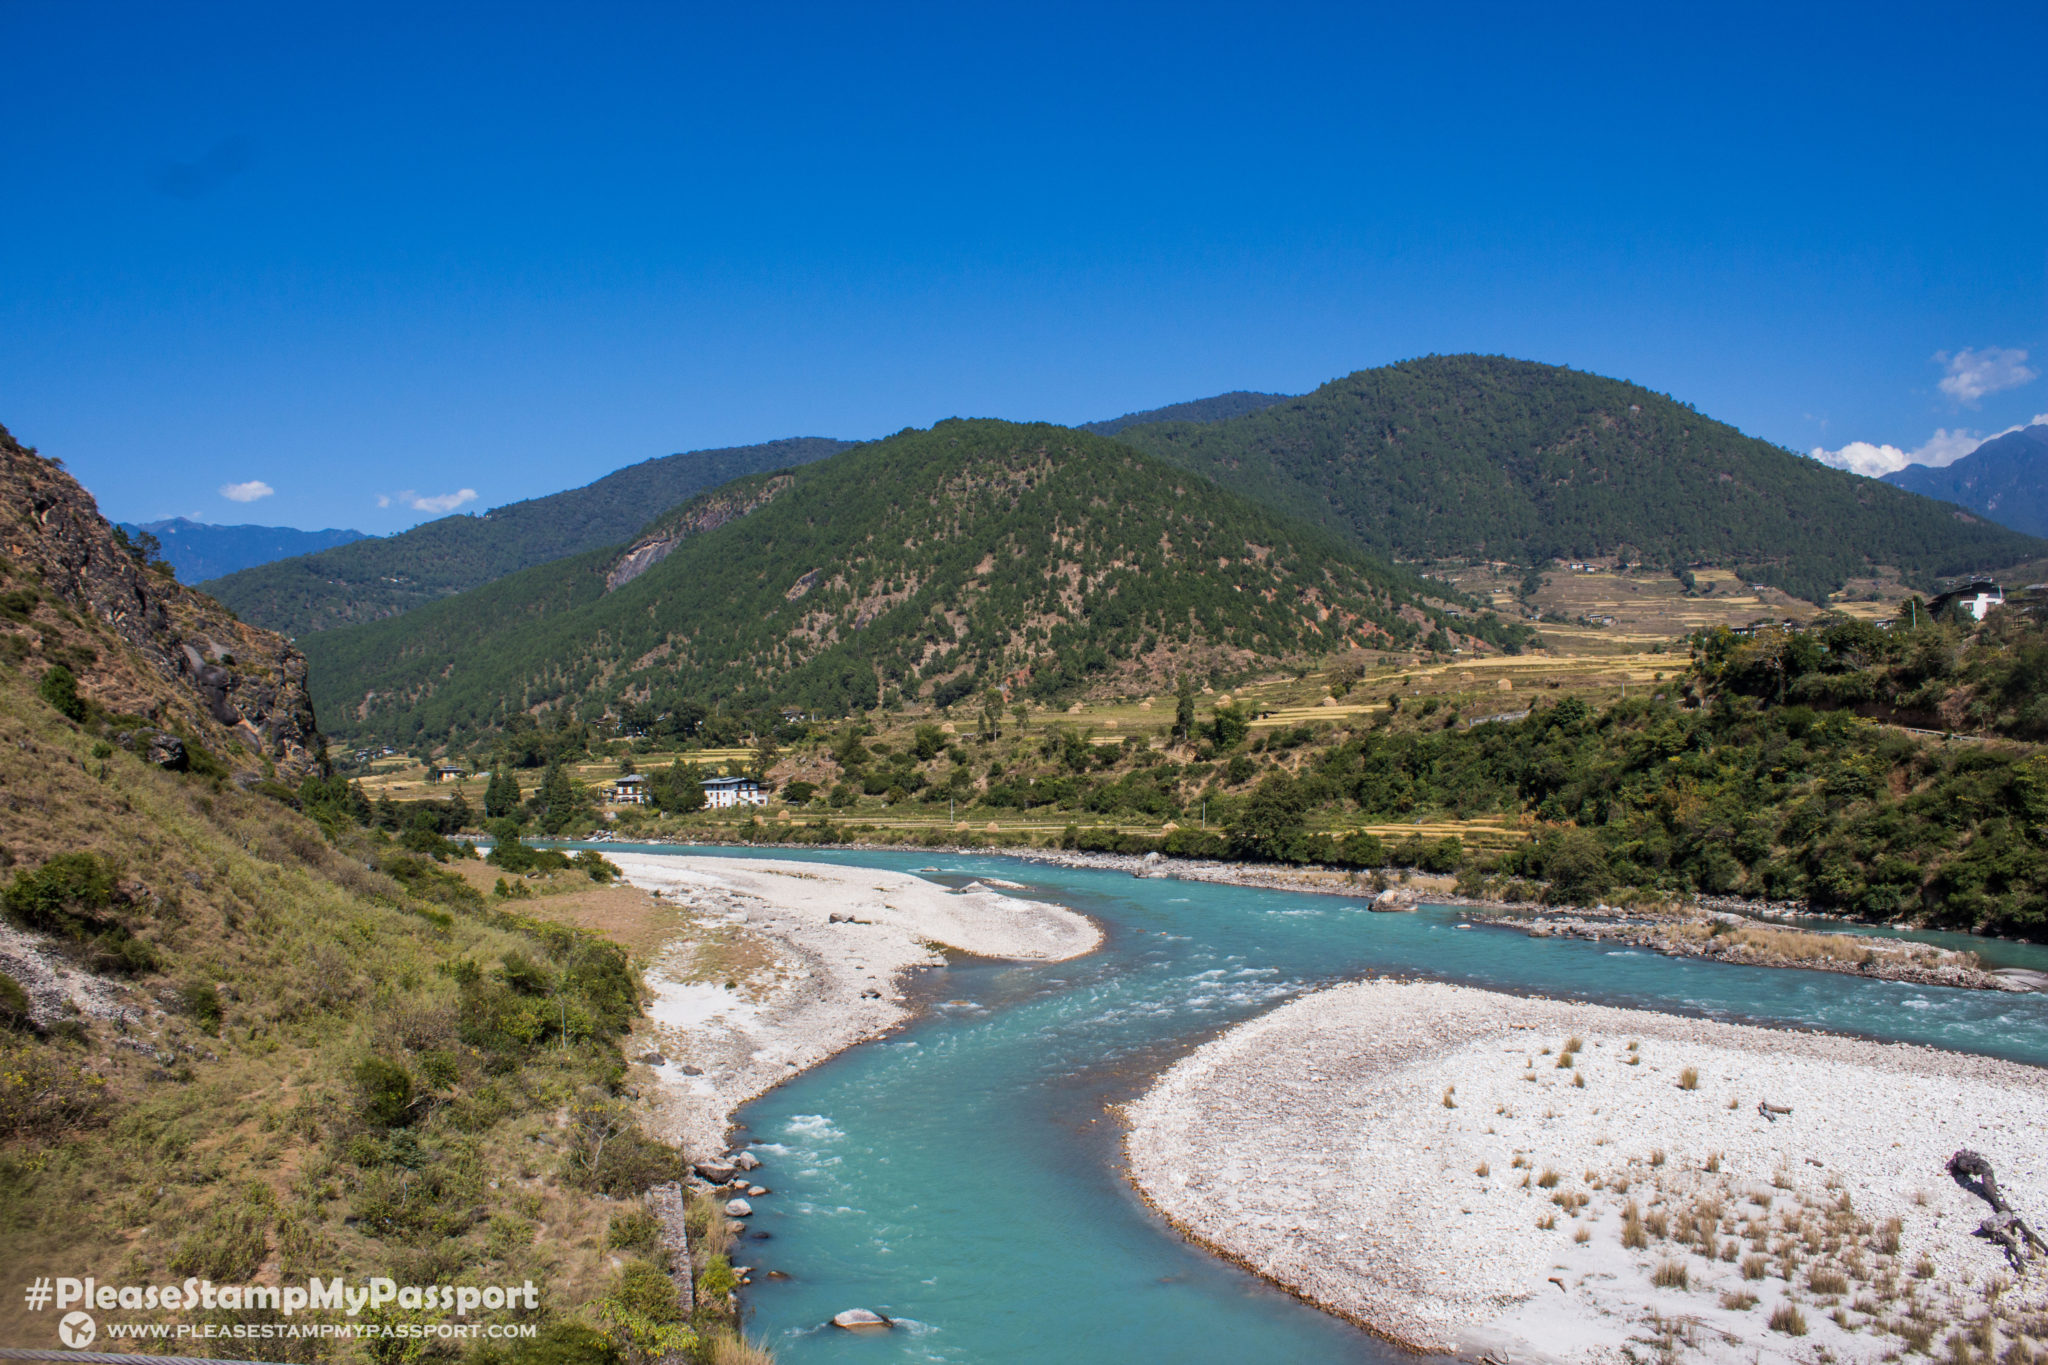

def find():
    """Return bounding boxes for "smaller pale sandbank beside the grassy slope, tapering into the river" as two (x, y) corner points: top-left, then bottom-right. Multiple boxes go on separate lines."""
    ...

(606, 853), (1102, 1158)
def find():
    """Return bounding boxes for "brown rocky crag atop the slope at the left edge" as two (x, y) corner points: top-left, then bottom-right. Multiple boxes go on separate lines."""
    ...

(0, 428), (319, 778)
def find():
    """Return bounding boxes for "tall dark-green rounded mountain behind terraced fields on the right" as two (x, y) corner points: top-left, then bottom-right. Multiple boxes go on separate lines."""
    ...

(1118, 356), (2048, 600)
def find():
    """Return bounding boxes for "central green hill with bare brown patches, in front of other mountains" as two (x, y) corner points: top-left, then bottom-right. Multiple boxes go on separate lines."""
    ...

(303, 420), (1520, 743)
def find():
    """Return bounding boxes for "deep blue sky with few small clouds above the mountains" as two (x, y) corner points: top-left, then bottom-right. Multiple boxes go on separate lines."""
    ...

(0, 0), (2048, 532)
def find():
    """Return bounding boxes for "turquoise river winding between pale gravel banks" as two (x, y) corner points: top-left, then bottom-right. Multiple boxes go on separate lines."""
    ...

(581, 845), (2048, 1365)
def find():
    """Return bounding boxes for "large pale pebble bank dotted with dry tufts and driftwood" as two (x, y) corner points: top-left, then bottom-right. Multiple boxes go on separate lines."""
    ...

(1126, 982), (2048, 1365)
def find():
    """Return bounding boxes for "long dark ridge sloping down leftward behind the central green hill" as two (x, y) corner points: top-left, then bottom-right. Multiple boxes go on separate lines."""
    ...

(207, 436), (848, 636)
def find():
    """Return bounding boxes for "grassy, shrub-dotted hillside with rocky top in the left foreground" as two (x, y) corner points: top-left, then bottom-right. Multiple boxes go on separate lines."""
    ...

(0, 454), (761, 1365)
